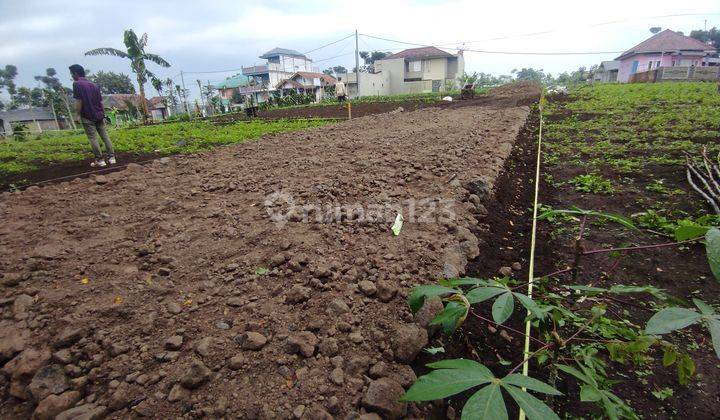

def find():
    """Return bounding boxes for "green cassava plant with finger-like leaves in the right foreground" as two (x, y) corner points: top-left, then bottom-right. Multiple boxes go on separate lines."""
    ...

(403, 208), (720, 420)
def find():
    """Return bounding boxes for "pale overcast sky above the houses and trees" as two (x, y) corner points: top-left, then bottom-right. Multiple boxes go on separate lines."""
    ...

(0, 0), (720, 100)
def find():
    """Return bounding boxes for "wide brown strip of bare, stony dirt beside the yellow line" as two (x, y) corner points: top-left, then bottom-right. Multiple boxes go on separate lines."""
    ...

(0, 85), (533, 419)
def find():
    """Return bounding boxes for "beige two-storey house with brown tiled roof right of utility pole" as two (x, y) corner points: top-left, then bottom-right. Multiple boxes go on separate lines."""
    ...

(338, 47), (465, 96)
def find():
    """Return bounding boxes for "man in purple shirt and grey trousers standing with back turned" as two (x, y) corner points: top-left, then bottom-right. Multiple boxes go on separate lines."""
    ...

(70, 64), (116, 168)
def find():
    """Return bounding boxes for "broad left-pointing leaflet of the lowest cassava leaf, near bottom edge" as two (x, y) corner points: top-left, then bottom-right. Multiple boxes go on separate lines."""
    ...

(401, 365), (493, 401)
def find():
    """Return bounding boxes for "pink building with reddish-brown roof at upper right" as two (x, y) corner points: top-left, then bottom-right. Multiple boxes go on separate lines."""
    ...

(615, 29), (717, 83)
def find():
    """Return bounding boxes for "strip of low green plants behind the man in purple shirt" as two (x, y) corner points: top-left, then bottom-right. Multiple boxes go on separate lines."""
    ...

(0, 120), (331, 175)
